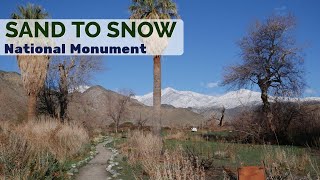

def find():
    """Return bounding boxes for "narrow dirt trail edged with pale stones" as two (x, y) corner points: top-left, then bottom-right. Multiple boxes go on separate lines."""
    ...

(75, 143), (112, 180)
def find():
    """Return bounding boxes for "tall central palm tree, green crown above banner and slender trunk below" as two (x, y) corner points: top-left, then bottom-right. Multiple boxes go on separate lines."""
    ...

(129, 0), (179, 133)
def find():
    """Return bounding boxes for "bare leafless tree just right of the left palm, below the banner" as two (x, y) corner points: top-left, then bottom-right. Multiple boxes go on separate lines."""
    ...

(41, 56), (103, 122)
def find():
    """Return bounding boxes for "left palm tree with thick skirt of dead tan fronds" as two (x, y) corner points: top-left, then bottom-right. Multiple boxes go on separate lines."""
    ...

(11, 4), (49, 120)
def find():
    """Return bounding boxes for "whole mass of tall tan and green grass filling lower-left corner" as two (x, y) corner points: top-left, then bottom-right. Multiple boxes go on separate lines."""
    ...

(0, 119), (89, 179)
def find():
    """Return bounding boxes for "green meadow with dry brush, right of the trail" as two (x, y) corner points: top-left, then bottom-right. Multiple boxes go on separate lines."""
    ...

(107, 126), (319, 179)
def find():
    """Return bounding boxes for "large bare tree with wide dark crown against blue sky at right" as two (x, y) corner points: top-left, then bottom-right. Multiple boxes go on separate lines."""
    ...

(222, 15), (305, 129)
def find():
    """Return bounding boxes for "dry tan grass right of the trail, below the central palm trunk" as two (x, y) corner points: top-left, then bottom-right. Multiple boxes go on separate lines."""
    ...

(122, 131), (205, 180)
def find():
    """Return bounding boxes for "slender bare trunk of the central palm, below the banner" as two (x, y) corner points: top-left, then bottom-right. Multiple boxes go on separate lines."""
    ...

(153, 55), (161, 134)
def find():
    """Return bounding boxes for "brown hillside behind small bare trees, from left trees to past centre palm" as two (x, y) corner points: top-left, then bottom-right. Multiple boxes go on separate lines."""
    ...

(69, 86), (204, 126)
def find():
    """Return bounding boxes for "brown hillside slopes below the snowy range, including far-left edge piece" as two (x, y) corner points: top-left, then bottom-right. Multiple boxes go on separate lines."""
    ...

(0, 71), (204, 126)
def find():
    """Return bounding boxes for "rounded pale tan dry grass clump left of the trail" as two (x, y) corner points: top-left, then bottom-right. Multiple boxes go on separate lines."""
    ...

(16, 120), (89, 161)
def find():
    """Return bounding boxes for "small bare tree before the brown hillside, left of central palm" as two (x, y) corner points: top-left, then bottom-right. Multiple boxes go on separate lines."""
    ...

(107, 90), (134, 134)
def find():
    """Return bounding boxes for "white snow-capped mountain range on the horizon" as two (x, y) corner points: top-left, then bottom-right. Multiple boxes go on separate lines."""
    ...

(135, 88), (320, 109)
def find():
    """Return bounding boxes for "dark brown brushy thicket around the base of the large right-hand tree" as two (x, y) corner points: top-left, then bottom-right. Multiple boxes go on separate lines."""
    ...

(232, 102), (319, 148)
